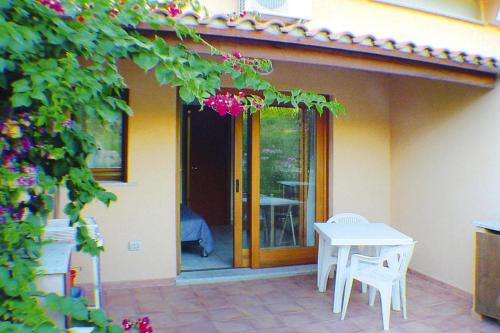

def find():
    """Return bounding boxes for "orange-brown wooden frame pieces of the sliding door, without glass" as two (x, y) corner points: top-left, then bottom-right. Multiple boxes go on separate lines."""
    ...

(176, 94), (330, 274)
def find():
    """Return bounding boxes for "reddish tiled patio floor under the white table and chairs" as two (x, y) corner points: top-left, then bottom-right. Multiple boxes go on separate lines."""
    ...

(99, 272), (500, 333)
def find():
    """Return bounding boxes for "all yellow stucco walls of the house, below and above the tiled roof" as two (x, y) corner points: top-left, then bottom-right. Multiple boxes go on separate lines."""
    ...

(63, 0), (500, 291)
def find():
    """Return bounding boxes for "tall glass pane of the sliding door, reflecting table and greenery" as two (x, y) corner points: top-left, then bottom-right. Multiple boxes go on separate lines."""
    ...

(260, 107), (316, 247)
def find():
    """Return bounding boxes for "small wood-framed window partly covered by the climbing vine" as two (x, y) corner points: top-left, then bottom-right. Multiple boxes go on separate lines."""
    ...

(85, 90), (128, 181)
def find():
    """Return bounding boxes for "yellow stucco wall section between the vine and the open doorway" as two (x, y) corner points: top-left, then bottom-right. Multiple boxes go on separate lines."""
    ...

(66, 61), (177, 282)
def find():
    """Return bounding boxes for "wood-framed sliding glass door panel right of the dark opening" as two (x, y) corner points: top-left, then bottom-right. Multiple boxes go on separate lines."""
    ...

(233, 107), (327, 267)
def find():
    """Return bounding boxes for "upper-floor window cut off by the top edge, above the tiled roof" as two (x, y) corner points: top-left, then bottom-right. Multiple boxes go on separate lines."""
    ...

(374, 0), (483, 23)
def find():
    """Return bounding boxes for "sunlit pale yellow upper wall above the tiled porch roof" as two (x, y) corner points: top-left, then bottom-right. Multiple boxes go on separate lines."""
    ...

(202, 0), (500, 57)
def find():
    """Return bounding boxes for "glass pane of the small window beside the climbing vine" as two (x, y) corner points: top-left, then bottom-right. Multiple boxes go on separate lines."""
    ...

(85, 118), (123, 169)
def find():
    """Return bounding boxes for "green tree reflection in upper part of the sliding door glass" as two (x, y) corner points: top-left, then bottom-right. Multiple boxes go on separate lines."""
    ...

(260, 107), (301, 196)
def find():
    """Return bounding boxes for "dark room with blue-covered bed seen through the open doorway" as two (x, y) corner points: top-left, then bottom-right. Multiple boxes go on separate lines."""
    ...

(180, 105), (233, 271)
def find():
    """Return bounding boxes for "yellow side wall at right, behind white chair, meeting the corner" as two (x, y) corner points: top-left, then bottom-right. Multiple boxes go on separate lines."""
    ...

(390, 78), (500, 292)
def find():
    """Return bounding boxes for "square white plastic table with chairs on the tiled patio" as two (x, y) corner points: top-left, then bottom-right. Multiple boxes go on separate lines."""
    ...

(314, 223), (413, 313)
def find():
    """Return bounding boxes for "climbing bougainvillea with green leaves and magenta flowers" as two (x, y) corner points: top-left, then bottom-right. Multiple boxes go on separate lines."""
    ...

(0, 0), (342, 333)
